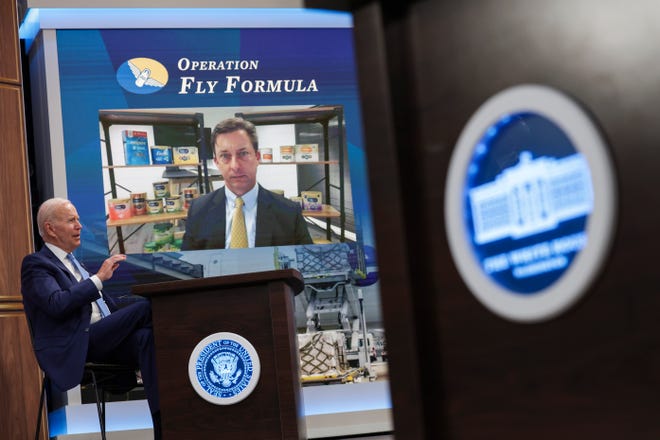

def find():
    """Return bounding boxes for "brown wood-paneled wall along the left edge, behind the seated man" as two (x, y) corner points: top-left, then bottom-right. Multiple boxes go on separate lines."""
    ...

(0, 0), (47, 439)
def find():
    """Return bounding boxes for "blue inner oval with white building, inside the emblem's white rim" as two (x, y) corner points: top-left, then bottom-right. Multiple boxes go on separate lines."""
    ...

(464, 112), (594, 295)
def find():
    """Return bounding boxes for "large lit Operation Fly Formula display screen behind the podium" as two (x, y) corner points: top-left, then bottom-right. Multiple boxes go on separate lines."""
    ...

(28, 8), (391, 436)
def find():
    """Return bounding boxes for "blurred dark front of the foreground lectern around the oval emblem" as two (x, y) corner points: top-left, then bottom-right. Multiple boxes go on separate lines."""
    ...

(390, 0), (660, 439)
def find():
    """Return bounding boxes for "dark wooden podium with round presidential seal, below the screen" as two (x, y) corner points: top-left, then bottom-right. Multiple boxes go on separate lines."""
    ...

(132, 269), (305, 440)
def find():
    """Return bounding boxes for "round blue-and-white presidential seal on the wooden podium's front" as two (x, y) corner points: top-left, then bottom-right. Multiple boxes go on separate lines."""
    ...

(188, 332), (261, 405)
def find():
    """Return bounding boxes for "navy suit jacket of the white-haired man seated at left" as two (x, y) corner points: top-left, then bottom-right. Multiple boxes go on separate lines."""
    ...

(21, 246), (117, 390)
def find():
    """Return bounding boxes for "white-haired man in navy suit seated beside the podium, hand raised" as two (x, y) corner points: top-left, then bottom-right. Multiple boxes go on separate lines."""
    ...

(21, 198), (161, 439)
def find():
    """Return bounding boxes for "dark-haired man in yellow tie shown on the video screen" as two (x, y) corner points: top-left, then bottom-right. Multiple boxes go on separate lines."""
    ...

(181, 118), (312, 250)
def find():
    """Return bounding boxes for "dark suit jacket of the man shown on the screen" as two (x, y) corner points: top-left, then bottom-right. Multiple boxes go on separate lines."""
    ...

(181, 185), (312, 250)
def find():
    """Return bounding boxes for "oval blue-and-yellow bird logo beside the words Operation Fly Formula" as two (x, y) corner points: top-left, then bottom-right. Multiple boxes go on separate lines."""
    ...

(117, 58), (169, 95)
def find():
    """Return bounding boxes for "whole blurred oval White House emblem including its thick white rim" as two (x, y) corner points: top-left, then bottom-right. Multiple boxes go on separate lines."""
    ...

(445, 85), (616, 322)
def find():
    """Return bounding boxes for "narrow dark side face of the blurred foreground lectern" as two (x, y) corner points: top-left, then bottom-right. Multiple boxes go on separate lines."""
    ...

(353, 3), (428, 440)
